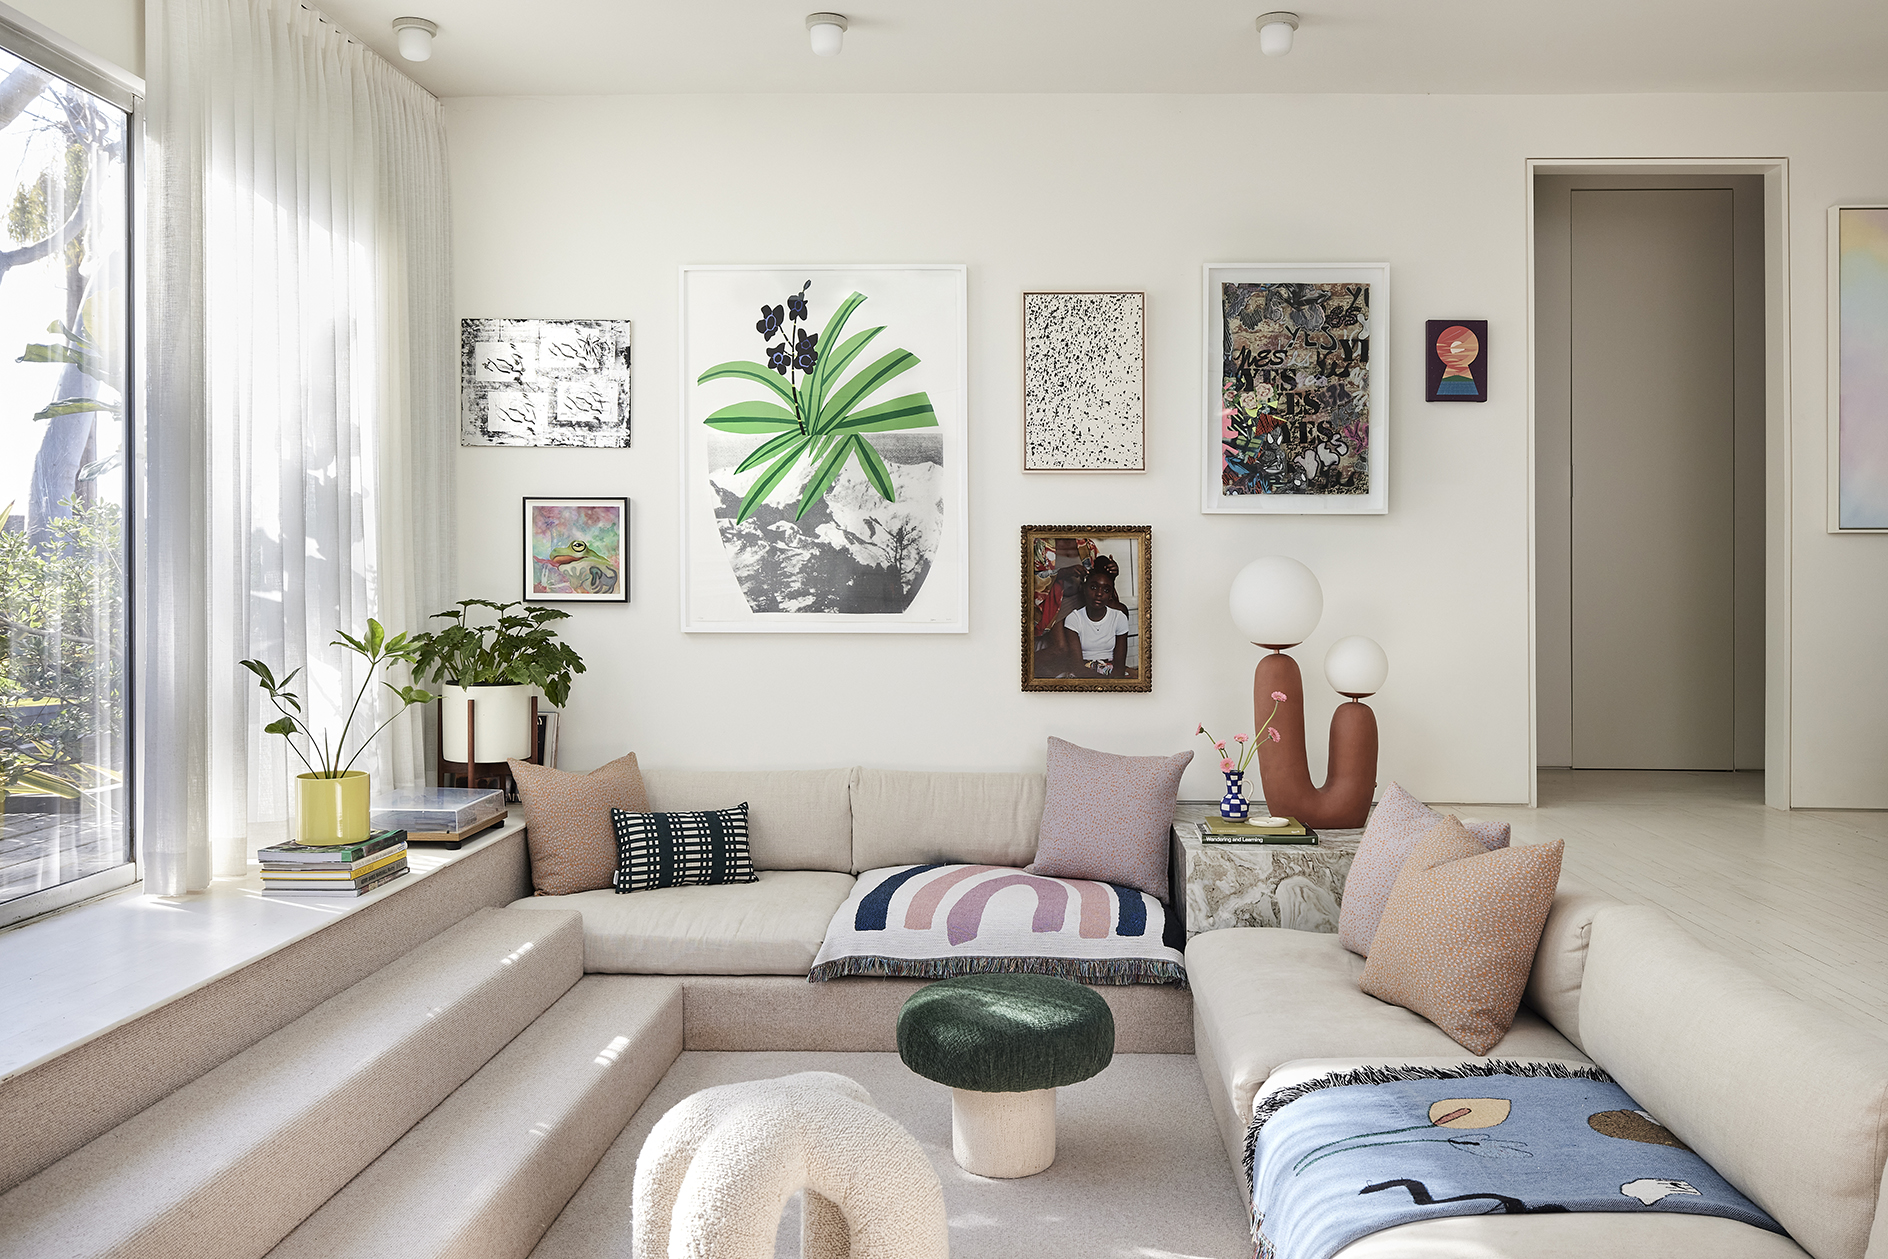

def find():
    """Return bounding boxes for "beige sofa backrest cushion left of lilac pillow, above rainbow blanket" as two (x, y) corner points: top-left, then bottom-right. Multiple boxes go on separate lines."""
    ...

(851, 770), (1048, 872)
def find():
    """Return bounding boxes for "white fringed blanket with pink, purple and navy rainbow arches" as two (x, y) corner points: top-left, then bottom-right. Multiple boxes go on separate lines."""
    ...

(808, 865), (1186, 985)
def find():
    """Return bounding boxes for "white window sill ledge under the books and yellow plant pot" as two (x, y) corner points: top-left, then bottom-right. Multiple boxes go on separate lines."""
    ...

(0, 815), (525, 1082)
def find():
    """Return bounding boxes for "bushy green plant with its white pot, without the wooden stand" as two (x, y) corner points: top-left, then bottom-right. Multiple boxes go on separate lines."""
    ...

(413, 598), (583, 763)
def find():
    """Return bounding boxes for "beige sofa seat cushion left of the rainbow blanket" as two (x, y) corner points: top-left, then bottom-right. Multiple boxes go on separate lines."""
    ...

(517, 870), (853, 976)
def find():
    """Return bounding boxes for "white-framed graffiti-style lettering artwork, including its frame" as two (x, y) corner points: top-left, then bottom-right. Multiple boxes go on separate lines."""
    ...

(1201, 262), (1390, 515)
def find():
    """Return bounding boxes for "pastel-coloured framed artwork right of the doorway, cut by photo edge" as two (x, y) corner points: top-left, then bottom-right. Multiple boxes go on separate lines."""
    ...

(1828, 206), (1888, 534)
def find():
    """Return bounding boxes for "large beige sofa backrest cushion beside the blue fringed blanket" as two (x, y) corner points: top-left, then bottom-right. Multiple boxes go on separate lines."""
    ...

(1578, 906), (1888, 1259)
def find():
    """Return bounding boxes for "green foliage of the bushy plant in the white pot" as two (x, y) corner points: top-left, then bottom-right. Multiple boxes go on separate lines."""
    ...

(412, 598), (583, 708)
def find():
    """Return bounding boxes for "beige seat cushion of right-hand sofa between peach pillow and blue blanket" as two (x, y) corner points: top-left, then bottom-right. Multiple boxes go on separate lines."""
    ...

(1186, 927), (1592, 1170)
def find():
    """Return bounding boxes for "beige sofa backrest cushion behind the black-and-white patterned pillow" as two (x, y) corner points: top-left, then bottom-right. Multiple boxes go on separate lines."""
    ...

(642, 768), (853, 874)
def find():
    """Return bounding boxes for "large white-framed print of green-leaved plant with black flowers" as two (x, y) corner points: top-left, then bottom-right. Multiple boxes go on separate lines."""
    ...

(680, 264), (970, 634)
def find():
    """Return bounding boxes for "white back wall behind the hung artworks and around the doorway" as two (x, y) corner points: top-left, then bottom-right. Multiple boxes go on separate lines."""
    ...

(447, 94), (1888, 808)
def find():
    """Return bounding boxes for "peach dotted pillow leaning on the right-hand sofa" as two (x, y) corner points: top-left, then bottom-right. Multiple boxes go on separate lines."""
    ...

(1359, 814), (1563, 1053)
